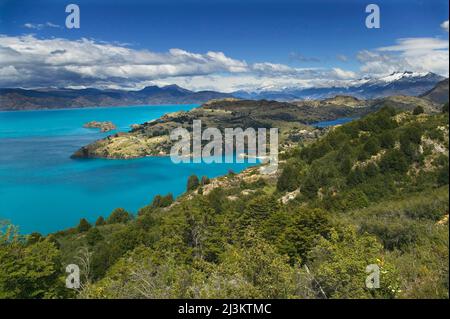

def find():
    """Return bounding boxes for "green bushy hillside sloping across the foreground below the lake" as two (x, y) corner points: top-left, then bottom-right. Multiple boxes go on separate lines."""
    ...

(0, 104), (449, 299)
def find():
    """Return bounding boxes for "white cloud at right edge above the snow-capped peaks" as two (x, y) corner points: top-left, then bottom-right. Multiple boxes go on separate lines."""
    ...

(357, 38), (449, 76)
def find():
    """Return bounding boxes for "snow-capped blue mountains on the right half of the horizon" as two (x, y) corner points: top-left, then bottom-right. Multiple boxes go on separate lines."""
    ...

(233, 71), (445, 101)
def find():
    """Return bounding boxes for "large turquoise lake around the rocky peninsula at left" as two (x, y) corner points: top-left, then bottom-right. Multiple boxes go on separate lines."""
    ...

(0, 105), (253, 233)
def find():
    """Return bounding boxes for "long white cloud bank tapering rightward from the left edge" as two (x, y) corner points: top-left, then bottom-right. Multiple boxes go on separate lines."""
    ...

(0, 35), (355, 91)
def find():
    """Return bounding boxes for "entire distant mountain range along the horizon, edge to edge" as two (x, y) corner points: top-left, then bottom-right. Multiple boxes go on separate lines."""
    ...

(0, 71), (448, 110)
